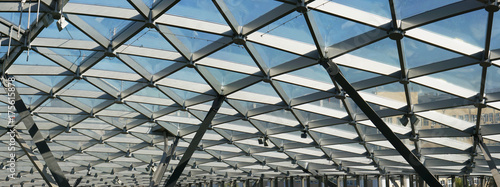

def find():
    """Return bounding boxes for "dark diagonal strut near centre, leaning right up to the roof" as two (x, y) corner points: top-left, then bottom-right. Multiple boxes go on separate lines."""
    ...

(165, 95), (226, 187)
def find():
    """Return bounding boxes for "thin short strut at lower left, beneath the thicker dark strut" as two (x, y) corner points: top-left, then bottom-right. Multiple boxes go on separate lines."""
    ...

(11, 129), (57, 187)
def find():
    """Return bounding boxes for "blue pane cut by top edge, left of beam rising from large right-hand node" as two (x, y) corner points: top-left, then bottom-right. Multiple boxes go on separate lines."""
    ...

(333, 0), (391, 18)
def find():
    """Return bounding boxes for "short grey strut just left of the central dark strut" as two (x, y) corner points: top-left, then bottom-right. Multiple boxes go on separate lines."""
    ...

(149, 136), (179, 187)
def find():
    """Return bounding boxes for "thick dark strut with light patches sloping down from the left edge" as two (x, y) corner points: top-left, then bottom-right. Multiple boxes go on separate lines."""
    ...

(1, 76), (70, 187)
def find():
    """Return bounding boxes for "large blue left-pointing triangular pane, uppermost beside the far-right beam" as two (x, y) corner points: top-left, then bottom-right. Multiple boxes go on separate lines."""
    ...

(422, 10), (488, 47)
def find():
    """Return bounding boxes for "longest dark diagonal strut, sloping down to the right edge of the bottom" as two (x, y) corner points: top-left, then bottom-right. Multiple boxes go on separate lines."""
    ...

(321, 59), (442, 186)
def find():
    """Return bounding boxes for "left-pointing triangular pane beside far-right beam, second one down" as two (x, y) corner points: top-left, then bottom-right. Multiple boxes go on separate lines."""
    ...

(429, 65), (482, 92)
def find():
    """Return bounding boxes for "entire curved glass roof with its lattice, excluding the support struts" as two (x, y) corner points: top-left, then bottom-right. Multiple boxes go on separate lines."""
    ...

(0, 0), (500, 186)
